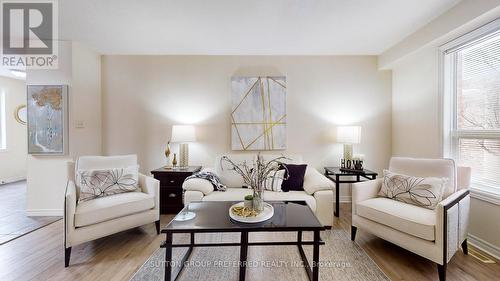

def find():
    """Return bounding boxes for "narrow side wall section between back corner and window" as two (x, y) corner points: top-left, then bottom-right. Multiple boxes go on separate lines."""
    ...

(392, 48), (441, 158)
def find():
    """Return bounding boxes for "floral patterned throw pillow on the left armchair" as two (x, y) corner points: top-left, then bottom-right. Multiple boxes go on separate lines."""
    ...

(76, 165), (139, 202)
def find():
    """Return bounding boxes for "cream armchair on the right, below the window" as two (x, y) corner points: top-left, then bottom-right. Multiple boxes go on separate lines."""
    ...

(351, 157), (470, 281)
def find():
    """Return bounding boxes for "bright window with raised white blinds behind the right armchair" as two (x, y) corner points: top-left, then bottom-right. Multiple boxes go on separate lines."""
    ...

(442, 21), (500, 193)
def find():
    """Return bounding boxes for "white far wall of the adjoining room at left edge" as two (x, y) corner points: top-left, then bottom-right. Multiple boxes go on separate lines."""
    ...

(0, 77), (27, 182)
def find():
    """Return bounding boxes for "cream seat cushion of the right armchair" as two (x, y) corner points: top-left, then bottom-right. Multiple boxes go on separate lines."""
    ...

(356, 198), (436, 241)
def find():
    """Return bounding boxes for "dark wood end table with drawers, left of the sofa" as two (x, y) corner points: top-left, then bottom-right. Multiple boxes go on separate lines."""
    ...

(151, 166), (201, 214)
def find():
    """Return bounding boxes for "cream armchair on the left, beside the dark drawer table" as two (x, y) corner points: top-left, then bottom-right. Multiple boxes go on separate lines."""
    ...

(64, 155), (160, 267)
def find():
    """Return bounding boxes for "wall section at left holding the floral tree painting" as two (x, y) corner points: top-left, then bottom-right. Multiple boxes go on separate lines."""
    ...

(26, 41), (101, 215)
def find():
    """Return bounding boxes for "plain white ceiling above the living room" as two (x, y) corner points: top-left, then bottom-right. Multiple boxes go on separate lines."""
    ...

(59, 0), (460, 55)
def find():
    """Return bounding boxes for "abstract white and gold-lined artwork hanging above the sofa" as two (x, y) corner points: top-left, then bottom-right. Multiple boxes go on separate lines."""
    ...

(231, 76), (286, 150)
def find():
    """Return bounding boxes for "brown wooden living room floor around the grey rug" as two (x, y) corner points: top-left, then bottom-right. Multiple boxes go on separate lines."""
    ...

(0, 204), (500, 281)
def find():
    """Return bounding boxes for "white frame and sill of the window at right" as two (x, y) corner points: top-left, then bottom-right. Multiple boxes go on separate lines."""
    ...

(439, 19), (500, 205)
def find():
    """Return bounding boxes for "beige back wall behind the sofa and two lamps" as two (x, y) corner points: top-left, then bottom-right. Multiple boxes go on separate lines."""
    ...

(102, 56), (391, 199)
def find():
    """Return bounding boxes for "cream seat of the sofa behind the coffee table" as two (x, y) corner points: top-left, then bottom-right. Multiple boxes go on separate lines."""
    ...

(202, 188), (316, 211)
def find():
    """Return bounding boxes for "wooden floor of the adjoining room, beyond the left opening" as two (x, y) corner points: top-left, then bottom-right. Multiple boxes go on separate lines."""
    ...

(0, 181), (60, 245)
